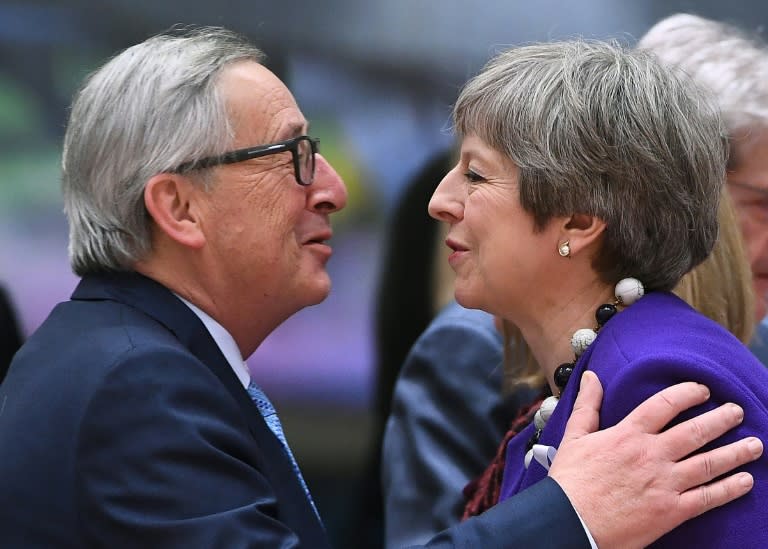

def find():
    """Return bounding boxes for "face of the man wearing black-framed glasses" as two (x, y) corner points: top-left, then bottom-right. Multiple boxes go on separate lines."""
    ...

(203, 61), (347, 330)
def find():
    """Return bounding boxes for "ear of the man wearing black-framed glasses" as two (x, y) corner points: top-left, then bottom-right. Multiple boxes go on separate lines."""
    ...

(144, 173), (205, 248)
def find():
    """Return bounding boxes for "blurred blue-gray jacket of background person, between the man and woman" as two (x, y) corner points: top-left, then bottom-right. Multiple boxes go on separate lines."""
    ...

(381, 301), (539, 549)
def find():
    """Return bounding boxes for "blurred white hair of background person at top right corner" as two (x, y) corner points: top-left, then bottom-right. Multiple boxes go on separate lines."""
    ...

(637, 13), (768, 134)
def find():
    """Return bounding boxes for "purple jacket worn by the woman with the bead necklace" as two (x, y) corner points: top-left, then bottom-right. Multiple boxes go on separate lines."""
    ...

(500, 292), (768, 548)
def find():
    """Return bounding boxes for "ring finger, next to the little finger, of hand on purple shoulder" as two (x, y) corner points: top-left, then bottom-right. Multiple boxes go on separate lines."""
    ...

(673, 437), (763, 493)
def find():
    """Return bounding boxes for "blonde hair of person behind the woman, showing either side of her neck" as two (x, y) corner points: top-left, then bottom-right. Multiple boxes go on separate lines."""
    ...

(502, 189), (755, 393)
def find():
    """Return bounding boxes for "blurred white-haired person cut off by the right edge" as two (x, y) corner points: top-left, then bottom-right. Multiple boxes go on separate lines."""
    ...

(638, 14), (768, 364)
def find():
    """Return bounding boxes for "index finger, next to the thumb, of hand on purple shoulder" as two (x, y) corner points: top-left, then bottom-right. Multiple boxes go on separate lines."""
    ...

(619, 381), (709, 433)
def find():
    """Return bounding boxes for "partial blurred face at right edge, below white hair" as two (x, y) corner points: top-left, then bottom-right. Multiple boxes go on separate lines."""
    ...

(728, 130), (768, 320)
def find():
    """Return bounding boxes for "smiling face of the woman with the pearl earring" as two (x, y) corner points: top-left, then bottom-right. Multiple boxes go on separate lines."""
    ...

(429, 135), (563, 322)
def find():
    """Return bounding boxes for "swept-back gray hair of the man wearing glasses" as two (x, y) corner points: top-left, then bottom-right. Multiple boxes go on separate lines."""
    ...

(62, 27), (263, 276)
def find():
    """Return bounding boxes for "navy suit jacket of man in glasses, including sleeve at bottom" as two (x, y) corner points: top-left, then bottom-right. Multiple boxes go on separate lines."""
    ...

(0, 273), (584, 549)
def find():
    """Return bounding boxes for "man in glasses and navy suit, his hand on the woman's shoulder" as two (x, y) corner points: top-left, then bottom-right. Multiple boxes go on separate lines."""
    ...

(0, 29), (762, 549)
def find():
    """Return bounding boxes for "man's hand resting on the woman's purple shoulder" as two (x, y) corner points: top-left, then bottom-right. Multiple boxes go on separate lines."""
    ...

(549, 371), (763, 549)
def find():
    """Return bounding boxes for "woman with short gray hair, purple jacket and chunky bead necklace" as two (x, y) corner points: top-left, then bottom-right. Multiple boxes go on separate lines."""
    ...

(429, 42), (768, 547)
